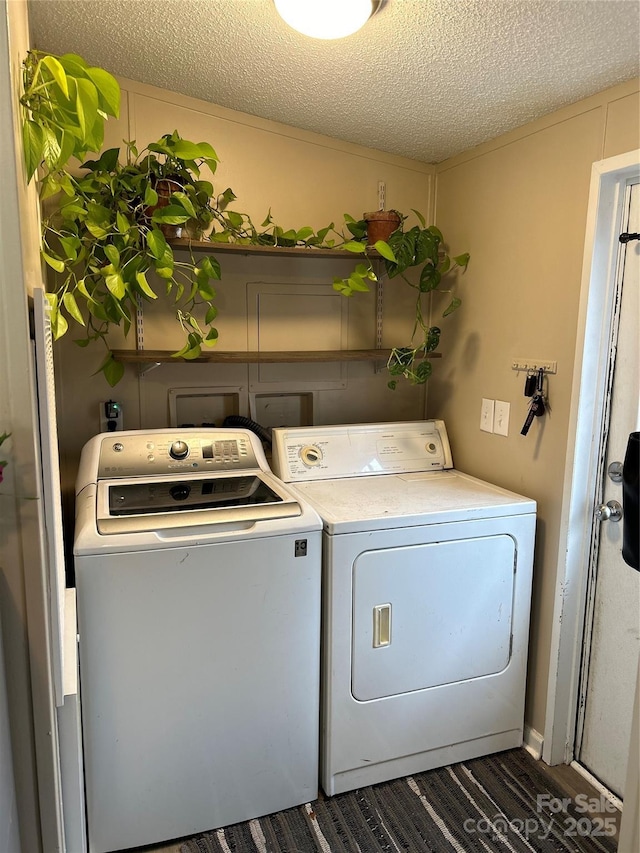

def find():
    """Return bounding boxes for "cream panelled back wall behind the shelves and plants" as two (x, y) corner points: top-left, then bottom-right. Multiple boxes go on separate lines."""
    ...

(55, 80), (434, 520)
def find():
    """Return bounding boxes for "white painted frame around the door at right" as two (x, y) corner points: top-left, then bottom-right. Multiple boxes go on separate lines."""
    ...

(542, 149), (640, 765)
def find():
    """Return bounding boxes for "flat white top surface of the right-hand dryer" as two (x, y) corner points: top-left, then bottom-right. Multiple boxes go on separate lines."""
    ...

(295, 471), (536, 534)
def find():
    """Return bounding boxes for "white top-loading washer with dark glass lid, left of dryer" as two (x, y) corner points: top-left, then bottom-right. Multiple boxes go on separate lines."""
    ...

(74, 429), (322, 853)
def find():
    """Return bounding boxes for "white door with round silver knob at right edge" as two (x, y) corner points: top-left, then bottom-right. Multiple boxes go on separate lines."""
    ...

(576, 184), (640, 796)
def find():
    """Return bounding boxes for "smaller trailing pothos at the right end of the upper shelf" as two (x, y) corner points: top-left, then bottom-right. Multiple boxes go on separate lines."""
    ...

(333, 210), (469, 390)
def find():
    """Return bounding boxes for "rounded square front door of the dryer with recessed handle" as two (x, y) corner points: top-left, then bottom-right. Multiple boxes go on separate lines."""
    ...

(351, 534), (516, 701)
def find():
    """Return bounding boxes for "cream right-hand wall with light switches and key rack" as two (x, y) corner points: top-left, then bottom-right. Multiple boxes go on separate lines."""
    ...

(428, 81), (640, 733)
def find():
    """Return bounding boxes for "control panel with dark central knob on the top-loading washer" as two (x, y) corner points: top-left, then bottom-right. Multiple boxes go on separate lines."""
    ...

(93, 429), (265, 479)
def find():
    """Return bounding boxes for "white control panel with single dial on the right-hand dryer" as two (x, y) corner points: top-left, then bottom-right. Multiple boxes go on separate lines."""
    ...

(271, 420), (453, 483)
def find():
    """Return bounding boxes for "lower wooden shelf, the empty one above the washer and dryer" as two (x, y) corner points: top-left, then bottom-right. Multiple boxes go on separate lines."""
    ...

(113, 349), (442, 364)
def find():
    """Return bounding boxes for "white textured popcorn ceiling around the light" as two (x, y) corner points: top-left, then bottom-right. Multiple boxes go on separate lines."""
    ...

(29, 0), (640, 163)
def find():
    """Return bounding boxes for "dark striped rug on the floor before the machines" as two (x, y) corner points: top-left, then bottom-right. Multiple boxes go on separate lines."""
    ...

(180, 749), (616, 853)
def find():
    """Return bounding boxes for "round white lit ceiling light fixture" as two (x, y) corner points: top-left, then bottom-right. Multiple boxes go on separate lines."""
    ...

(274, 0), (381, 39)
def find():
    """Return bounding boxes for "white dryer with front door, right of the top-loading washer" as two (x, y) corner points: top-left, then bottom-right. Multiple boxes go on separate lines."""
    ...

(272, 421), (536, 794)
